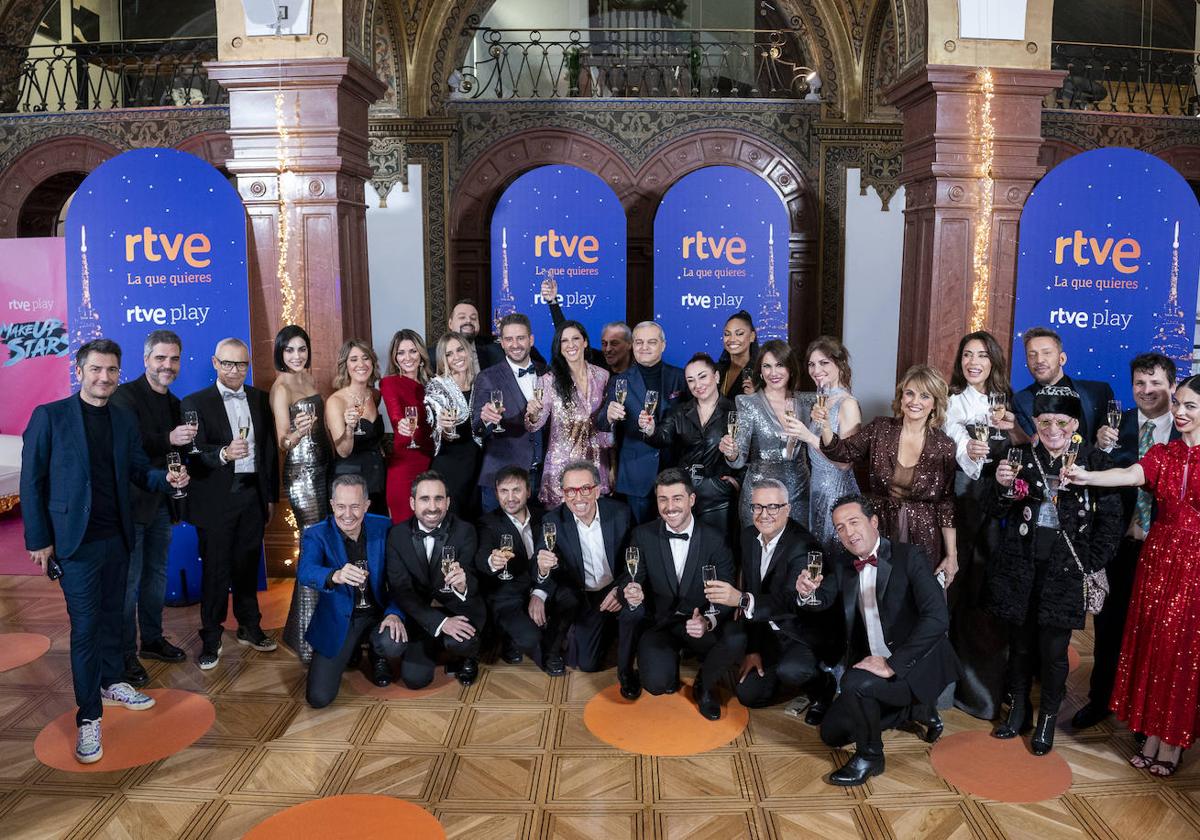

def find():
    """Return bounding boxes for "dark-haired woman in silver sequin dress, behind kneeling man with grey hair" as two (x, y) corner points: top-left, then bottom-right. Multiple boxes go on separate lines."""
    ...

(721, 338), (809, 528)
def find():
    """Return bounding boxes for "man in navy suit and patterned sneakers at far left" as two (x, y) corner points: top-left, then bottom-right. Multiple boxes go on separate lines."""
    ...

(20, 338), (188, 764)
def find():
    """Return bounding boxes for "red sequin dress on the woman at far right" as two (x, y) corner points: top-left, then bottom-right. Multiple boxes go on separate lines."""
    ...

(1112, 440), (1200, 746)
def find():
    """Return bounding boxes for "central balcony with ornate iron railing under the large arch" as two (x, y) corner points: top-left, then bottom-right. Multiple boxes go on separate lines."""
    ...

(450, 28), (820, 100)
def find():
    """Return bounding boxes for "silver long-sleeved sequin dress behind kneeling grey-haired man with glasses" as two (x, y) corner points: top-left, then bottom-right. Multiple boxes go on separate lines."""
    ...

(728, 391), (812, 528)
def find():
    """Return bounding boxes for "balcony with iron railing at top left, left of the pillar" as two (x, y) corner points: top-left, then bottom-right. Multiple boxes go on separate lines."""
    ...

(0, 37), (228, 113)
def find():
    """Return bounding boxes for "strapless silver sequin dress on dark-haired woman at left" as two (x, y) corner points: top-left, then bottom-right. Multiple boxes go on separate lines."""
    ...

(283, 394), (330, 662)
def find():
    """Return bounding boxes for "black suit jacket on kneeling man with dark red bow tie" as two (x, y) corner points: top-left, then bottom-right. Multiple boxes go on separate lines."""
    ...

(800, 539), (960, 704)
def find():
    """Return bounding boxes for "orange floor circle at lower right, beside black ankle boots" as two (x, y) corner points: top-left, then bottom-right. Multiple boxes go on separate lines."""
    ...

(929, 732), (1072, 803)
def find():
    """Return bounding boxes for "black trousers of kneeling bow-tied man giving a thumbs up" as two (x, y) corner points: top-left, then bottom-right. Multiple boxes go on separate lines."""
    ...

(643, 607), (746, 694)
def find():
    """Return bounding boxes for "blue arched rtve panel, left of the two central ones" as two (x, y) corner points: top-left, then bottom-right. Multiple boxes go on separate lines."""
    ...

(485, 166), (625, 359)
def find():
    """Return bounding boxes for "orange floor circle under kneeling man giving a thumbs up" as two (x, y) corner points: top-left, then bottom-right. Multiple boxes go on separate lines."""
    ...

(583, 680), (750, 756)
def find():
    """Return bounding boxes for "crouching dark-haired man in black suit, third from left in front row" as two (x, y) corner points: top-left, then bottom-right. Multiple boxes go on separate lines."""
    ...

(475, 467), (563, 676)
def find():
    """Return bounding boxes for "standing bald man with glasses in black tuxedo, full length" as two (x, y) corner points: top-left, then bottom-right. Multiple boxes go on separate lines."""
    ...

(181, 338), (280, 671)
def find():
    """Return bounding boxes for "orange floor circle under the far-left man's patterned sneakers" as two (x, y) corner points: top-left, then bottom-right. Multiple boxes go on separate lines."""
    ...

(34, 689), (217, 773)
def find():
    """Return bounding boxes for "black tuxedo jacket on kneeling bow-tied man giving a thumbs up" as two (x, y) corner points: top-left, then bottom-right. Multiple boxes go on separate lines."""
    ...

(617, 517), (733, 628)
